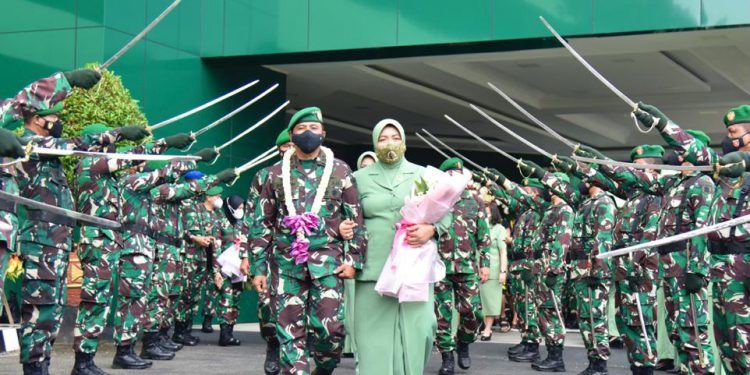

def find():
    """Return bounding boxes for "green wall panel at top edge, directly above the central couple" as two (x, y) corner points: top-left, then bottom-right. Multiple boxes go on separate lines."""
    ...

(309, 0), (398, 51)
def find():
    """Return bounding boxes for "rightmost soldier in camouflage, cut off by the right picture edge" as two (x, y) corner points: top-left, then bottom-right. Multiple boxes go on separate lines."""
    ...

(708, 105), (750, 374)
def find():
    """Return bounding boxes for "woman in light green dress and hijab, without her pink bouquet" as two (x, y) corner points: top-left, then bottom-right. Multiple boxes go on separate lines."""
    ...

(354, 119), (450, 375)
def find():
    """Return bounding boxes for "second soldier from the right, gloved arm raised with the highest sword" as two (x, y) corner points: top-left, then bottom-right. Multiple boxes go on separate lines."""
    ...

(635, 103), (716, 374)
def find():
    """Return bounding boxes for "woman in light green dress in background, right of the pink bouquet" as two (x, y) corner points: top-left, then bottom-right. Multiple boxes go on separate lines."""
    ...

(479, 204), (508, 341)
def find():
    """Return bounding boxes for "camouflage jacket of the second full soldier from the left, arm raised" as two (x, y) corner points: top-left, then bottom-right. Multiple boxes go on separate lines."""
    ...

(76, 140), (167, 245)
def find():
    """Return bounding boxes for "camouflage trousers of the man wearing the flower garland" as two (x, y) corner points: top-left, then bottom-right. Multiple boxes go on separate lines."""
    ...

(274, 275), (345, 375)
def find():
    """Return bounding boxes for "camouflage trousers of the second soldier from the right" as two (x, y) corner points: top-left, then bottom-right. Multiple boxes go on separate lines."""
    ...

(662, 277), (714, 374)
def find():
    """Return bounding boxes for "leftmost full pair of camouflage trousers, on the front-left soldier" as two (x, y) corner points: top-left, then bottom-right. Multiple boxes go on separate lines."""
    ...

(20, 241), (70, 363)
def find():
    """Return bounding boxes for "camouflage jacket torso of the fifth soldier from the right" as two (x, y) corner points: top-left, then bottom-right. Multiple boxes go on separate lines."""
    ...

(533, 203), (574, 275)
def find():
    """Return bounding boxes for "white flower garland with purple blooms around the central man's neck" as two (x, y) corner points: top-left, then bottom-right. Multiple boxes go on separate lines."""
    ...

(281, 147), (333, 264)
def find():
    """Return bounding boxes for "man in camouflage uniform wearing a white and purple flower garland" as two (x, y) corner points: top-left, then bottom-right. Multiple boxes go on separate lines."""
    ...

(249, 107), (367, 375)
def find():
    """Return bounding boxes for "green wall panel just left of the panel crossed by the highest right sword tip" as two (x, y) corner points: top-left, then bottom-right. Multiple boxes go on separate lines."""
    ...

(398, 0), (493, 46)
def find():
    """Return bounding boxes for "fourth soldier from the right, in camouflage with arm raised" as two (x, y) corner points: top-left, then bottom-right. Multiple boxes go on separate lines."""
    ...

(520, 161), (615, 375)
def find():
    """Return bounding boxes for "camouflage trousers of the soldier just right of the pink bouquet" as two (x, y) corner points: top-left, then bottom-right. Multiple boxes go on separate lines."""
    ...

(435, 273), (483, 353)
